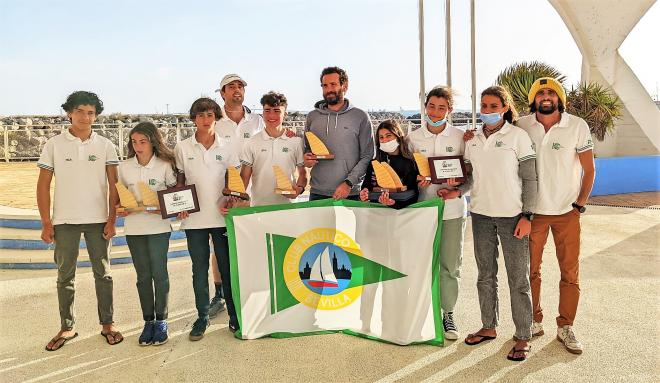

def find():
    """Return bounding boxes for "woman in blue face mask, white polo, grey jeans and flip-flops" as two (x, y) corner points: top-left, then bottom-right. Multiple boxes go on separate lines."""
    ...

(465, 86), (537, 361)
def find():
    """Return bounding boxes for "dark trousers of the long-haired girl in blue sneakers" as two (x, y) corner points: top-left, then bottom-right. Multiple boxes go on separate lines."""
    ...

(126, 232), (172, 321)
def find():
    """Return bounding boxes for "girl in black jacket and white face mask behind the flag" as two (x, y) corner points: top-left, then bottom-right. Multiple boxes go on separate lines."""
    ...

(360, 120), (417, 209)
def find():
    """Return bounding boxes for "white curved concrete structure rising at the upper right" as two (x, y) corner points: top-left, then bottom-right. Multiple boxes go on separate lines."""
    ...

(548, 0), (660, 157)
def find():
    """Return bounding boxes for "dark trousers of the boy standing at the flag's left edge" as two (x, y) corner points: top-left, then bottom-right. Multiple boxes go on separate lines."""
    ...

(186, 227), (236, 320)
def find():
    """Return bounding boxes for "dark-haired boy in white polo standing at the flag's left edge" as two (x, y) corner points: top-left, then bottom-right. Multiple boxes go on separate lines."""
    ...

(175, 98), (240, 340)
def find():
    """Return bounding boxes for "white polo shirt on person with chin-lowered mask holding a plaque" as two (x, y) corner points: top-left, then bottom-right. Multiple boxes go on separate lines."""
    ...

(408, 123), (467, 220)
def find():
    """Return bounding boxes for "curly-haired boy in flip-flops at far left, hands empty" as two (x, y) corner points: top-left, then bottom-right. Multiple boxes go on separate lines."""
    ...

(37, 91), (124, 351)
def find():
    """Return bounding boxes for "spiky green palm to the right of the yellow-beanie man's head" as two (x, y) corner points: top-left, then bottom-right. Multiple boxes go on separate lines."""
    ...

(566, 82), (622, 141)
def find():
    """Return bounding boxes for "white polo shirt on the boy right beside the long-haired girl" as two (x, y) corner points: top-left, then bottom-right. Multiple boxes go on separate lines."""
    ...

(174, 132), (240, 230)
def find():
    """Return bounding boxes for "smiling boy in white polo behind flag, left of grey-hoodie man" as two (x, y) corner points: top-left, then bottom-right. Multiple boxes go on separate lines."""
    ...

(241, 92), (307, 206)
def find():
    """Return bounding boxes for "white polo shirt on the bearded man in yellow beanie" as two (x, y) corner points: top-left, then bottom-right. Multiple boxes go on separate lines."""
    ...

(516, 113), (594, 215)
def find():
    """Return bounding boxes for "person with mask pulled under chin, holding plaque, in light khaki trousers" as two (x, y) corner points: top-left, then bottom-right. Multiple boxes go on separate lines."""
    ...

(408, 86), (472, 340)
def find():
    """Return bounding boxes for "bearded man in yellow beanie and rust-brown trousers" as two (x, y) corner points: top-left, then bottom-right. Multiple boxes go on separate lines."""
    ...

(517, 77), (596, 354)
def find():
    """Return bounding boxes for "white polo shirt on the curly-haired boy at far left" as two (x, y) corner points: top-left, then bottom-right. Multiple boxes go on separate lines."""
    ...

(37, 129), (119, 225)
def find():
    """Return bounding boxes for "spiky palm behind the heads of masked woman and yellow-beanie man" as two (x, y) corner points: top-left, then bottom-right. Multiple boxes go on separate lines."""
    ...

(495, 61), (566, 115)
